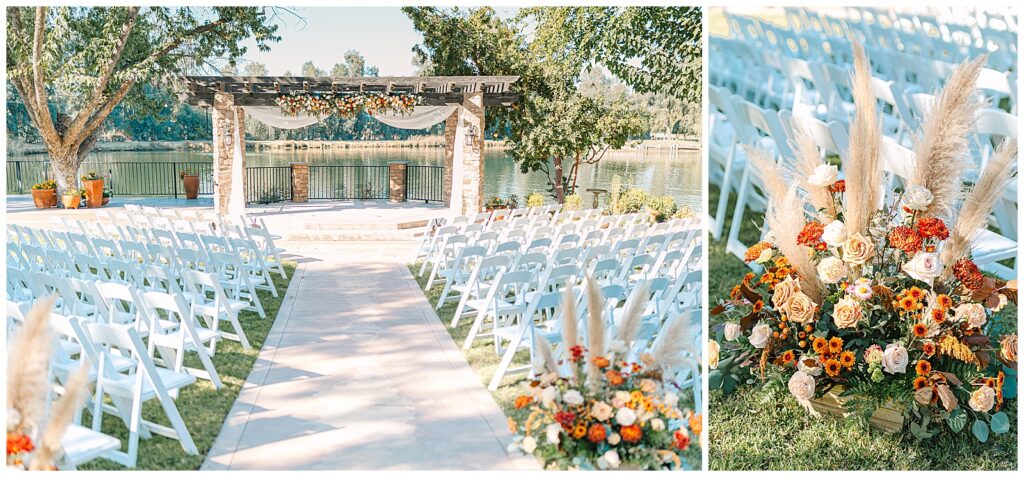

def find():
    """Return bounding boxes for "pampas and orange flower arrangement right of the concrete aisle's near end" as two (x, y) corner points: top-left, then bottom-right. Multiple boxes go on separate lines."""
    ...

(509, 279), (701, 470)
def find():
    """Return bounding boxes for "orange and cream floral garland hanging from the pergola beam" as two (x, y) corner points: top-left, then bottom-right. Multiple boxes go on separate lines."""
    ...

(275, 91), (420, 118)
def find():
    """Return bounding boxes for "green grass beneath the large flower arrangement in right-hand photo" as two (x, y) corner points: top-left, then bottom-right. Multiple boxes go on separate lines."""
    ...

(708, 184), (1017, 470)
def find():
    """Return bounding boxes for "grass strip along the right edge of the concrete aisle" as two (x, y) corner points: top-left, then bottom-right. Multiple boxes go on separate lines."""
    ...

(409, 262), (702, 470)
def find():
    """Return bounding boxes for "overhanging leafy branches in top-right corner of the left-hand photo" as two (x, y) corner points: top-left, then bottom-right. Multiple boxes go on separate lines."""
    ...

(519, 6), (701, 103)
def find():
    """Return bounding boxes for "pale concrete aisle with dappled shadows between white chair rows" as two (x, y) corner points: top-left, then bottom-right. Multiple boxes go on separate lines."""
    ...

(203, 243), (539, 470)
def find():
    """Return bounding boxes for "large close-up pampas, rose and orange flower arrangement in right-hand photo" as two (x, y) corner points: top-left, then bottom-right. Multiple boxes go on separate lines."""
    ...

(709, 46), (1017, 441)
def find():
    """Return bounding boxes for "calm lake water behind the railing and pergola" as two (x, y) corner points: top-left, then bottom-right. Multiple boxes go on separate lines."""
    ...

(7, 147), (703, 211)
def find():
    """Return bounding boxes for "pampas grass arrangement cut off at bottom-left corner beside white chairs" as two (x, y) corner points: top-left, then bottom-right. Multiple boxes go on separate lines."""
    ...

(7, 296), (90, 470)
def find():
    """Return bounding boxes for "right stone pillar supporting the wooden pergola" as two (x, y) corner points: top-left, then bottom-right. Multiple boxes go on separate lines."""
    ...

(456, 92), (485, 215)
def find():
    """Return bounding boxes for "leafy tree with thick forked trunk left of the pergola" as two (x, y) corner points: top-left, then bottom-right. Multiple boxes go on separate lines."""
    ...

(7, 6), (280, 190)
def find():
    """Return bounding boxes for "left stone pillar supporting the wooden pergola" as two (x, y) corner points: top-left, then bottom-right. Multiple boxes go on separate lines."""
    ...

(212, 92), (246, 214)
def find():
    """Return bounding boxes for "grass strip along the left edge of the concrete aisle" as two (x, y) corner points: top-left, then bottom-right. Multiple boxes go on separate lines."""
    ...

(80, 261), (295, 470)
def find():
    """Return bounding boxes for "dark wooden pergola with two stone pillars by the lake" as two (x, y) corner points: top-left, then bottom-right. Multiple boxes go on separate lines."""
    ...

(182, 76), (521, 214)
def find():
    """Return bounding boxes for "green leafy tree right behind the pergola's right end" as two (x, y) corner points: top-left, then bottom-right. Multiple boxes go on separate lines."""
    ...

(402, 7), (645, 203)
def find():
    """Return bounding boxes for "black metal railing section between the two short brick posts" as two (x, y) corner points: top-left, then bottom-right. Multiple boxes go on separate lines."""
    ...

(309, 166), (391, 200)
